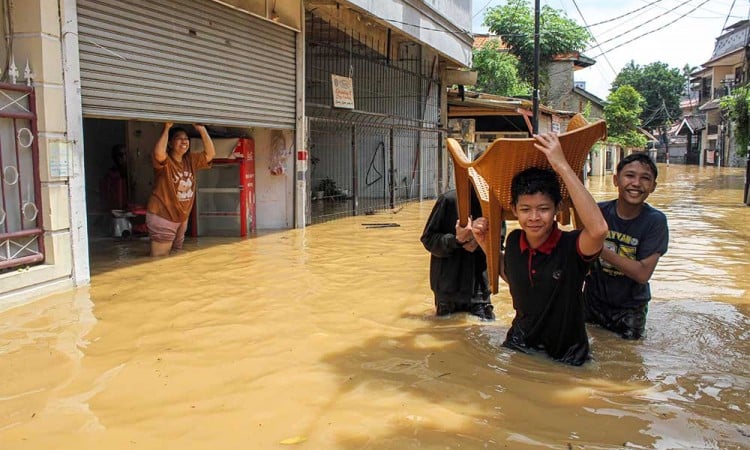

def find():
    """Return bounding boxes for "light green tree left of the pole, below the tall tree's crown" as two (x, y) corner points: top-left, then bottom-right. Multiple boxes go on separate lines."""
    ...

(472, 39), (531, 97)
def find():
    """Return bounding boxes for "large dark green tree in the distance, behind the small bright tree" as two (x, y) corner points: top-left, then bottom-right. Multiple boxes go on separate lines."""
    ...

(612, 61), (685, 128)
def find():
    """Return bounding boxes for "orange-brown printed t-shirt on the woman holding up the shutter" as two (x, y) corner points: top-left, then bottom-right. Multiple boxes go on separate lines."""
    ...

(148, 152), (211, 223)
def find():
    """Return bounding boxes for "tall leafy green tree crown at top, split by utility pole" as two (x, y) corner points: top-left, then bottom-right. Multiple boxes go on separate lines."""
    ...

(484, 0), (591, 85)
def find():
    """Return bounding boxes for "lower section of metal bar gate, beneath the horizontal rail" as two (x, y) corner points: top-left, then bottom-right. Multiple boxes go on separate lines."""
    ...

(308, 117), (444, 223)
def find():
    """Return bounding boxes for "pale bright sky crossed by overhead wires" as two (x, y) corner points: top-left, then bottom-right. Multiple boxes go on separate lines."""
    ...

(472, 0), (750, 99)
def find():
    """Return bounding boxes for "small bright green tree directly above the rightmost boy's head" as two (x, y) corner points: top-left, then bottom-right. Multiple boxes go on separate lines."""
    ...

(604, 85), (647, 148)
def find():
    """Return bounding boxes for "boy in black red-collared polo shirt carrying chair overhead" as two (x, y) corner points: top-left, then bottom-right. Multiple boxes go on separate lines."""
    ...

(472, 133), (607, 365)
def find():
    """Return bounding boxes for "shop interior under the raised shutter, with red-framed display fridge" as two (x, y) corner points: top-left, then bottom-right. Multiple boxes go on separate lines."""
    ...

(83, 118), (294, 253)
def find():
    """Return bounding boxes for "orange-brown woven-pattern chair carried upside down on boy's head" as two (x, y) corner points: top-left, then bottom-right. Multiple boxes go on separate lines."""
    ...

(447, 114), (607, 294)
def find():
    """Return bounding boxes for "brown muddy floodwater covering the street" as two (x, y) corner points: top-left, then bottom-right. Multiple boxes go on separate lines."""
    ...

(0, 165), (750, 450)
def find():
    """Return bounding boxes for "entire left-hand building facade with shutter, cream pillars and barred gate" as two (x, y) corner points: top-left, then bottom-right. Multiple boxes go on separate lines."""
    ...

(0, 0), (471, 309)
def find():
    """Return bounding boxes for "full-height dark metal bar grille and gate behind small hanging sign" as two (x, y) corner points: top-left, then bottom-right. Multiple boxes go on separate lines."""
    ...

(305, 11), (443, 223)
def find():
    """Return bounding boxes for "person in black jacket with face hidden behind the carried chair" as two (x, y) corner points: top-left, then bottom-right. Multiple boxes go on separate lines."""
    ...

(420, 181), (495, 320)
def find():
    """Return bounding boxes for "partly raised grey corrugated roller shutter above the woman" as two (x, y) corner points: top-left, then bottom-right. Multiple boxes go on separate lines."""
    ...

(78, 0), (296, 129)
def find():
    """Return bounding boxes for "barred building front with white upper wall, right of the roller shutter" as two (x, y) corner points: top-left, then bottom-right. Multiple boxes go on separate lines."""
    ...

(305, 0), (472, 222)
